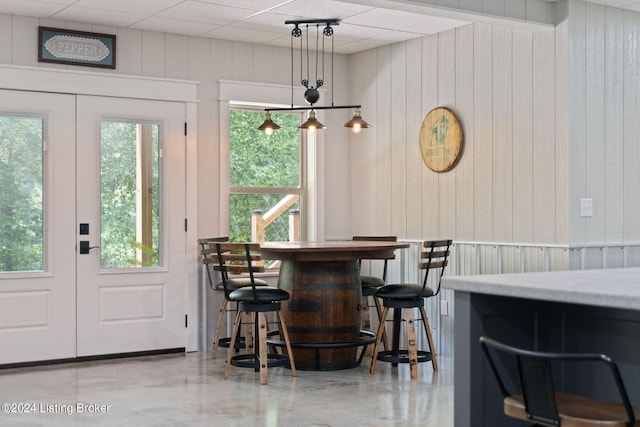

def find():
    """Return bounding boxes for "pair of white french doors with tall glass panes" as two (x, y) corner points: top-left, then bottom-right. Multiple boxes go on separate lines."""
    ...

(0, 91), (186, 364)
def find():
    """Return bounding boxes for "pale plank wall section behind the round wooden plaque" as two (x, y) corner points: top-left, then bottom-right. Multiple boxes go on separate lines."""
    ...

(350, 23), (568, 244)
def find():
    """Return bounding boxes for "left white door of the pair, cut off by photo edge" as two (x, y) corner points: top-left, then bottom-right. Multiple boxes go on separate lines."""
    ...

(0, 90), (76, 364)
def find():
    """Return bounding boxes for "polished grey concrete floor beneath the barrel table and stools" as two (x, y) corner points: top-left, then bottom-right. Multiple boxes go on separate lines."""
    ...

(0, 350), (453, 427)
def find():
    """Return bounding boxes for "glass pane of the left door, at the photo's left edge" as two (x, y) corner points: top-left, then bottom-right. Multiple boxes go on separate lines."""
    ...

(0, 115), (45, 272)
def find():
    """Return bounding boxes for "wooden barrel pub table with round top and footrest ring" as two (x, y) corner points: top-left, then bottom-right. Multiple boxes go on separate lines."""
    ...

(259, 241), (409, 371)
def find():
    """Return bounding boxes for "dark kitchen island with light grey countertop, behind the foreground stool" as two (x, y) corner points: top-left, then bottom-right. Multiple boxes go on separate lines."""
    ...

(442, 268), (640, 427)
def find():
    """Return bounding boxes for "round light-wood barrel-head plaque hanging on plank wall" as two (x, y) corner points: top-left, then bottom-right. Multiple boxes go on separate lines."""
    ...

(420, 107), (462, 172)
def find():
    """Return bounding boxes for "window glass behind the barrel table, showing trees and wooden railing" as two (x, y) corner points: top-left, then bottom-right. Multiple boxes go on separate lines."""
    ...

(229, 107), (304, 241)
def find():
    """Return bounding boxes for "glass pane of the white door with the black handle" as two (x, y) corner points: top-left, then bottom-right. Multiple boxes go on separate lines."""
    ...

(100, 120), (161, 268)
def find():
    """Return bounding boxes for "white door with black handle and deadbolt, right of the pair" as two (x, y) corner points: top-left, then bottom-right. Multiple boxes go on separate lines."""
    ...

(76, 96), (186, 356)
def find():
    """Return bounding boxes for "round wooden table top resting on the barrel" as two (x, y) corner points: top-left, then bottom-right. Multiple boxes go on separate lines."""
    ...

(256, 240), (409, 261)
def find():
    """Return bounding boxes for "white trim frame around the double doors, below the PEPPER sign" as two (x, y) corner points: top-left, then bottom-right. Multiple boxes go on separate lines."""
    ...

(0, 65), (201, 351)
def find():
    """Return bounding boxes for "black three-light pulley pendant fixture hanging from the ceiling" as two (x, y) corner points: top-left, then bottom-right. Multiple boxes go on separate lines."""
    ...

(258, 19), (371, 135)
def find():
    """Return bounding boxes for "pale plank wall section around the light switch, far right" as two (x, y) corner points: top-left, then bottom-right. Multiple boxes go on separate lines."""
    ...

(569, 0), (640, 244)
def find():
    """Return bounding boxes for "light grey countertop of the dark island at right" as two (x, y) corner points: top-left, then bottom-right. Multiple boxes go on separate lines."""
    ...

(442, 268), (640, 310)
